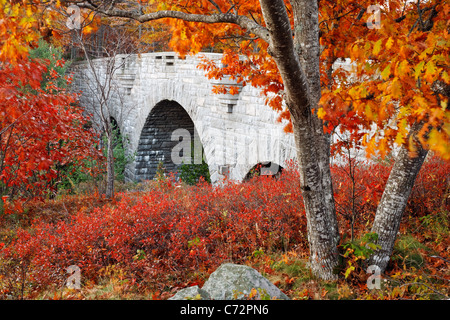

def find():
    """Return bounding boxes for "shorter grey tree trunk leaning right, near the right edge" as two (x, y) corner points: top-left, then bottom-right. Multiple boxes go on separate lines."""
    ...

(369, 124), (428, 272)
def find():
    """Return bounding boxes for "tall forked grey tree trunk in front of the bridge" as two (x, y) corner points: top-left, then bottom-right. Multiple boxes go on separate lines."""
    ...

(260, 0), (339, 280)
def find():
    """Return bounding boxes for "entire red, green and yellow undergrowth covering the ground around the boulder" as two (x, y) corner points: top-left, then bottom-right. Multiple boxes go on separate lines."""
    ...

(0, 159), (450, 299)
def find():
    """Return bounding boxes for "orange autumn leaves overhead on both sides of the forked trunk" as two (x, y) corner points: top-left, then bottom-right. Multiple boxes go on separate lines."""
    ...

(158, 0), (450, 160)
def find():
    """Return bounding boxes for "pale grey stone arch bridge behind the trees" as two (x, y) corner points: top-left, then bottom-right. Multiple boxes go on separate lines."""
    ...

(71, 52), (296, 184)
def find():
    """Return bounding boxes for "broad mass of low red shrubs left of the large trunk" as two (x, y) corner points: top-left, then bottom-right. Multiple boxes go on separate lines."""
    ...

(0, 173), (306, 298)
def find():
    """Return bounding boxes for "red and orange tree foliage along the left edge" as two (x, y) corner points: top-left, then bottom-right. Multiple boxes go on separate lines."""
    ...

(0, 3), (100, 212)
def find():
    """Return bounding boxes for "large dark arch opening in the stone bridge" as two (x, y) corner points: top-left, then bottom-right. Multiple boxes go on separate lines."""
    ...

(135, 100), (207, 181)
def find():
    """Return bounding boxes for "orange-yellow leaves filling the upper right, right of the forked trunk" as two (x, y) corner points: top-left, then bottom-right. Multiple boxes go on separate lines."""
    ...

(320, 1), (450, 160)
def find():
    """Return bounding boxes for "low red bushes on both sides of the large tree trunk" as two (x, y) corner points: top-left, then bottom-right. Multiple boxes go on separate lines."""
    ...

(0, 155), (450, 297)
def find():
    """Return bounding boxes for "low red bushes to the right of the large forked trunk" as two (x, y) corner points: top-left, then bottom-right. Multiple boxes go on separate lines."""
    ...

(331, 156), (450, 240)
